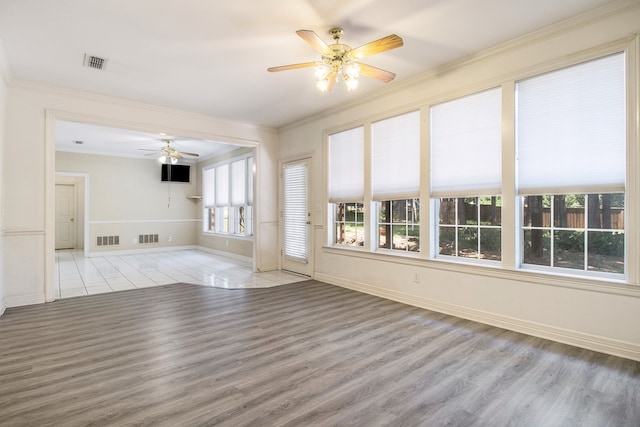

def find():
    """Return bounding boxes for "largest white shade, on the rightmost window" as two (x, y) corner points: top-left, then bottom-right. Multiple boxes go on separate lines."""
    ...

(516, 53), (626, 194)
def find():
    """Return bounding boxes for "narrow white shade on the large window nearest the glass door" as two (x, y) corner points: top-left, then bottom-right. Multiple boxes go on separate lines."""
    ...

(329, 126), (364, 203)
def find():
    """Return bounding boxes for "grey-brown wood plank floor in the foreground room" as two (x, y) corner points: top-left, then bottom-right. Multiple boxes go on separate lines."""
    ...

(0, 281), (640, 427)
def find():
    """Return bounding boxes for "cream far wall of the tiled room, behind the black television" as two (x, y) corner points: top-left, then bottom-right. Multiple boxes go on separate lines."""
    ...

(56, 152), (197, 254)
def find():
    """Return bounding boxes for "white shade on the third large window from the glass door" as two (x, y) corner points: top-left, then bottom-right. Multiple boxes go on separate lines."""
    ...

(431, 88), (502, 197)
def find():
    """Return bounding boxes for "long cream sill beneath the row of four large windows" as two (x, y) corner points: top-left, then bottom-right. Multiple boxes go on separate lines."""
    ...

(322, 246), (640, 298)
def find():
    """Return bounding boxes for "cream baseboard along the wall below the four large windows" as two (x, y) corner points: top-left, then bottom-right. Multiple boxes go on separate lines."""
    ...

(314, 273), (640, 361)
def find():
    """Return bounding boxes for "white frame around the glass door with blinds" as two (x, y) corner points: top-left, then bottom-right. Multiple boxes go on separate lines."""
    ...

(278, 154), (315, 279)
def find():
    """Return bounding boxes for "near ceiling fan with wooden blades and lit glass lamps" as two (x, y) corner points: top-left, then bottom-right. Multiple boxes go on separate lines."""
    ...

(267, 28), (403, 92)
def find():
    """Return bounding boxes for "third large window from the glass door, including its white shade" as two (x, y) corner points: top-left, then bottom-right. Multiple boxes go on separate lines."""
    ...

(431, 88), (502, 260)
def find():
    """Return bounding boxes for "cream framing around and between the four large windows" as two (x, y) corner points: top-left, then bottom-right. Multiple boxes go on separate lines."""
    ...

(323, 42), (640, 289)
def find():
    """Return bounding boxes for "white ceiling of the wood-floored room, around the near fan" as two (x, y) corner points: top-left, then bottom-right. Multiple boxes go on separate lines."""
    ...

(0, 0), (611, 160)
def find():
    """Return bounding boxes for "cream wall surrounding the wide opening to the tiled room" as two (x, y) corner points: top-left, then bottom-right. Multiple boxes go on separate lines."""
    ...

(2, 81), (277, 306)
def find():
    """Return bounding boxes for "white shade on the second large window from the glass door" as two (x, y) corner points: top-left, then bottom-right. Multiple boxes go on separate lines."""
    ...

(371, 111), (420, 201)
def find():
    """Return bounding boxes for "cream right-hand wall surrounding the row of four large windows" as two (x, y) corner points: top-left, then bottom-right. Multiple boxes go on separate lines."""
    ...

(279, 0), (640, 360)
